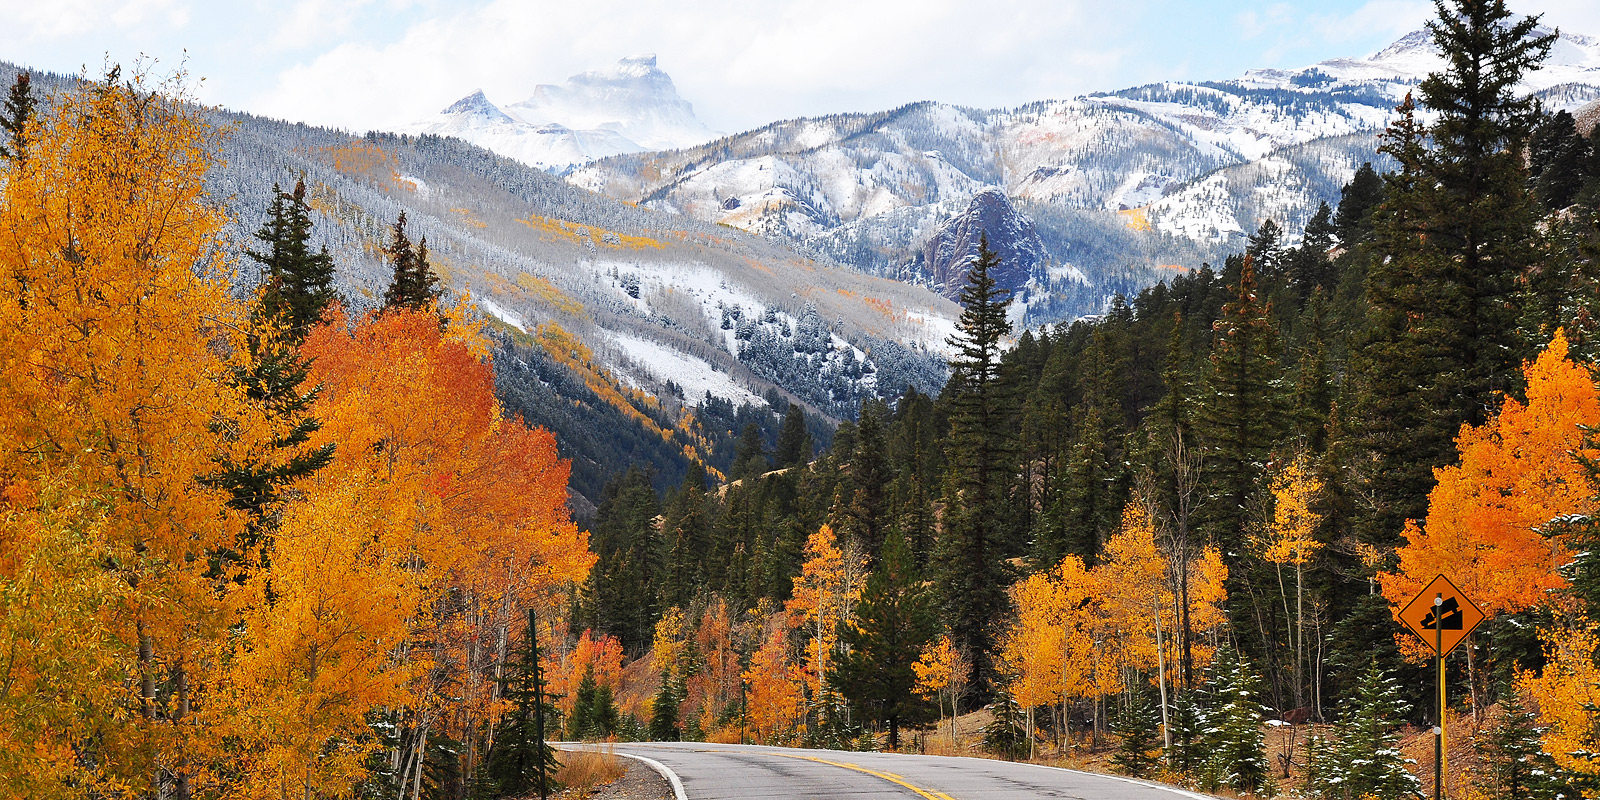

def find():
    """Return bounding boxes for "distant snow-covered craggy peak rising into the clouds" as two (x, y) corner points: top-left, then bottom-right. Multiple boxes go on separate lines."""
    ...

(405, 56), (715, 171)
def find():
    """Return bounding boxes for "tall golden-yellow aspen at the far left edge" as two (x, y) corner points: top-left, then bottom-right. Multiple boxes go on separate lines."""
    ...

(0, 70), (274, 797)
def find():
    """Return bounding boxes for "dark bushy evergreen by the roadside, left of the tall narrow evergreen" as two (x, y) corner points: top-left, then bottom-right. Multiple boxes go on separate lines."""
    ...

(835, 533), (939, 750)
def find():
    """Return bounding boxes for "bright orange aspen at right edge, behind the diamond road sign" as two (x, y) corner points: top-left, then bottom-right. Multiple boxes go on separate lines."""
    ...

(1378, 331), (1600, 658)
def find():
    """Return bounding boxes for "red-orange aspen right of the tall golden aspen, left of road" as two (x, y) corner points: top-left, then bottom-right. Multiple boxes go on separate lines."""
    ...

(284, 310), (594, 784)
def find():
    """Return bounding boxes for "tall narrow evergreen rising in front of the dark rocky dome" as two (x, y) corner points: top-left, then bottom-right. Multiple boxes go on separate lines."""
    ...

(938, 238), (1011, 691)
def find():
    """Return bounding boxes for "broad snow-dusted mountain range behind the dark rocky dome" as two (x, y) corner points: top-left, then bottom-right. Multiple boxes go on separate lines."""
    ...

(568, 32), (1600, 322)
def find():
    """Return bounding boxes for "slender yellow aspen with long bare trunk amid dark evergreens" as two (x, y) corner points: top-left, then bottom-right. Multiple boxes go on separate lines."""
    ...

(1256, 453), (1323, 707)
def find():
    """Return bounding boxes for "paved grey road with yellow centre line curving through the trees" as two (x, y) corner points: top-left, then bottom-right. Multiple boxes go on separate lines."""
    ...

(566, 742), (1211, 800)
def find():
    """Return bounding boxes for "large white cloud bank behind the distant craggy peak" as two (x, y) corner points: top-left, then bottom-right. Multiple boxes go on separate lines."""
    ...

(250, 0), (1133, 130)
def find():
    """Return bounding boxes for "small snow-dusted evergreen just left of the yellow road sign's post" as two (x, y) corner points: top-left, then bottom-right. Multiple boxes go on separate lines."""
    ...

(1307, 661), (1422, 800)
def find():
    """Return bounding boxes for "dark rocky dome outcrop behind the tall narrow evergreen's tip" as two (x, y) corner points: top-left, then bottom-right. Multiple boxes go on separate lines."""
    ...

(917, 189), (1048, 299)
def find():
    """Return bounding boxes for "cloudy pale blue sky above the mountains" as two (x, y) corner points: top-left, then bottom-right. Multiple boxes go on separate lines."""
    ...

(0, 0), (1600, 133)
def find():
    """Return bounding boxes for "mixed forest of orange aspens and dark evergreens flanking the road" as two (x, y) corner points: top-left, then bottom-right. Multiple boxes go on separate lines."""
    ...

(0, 0), (1600, 800)
